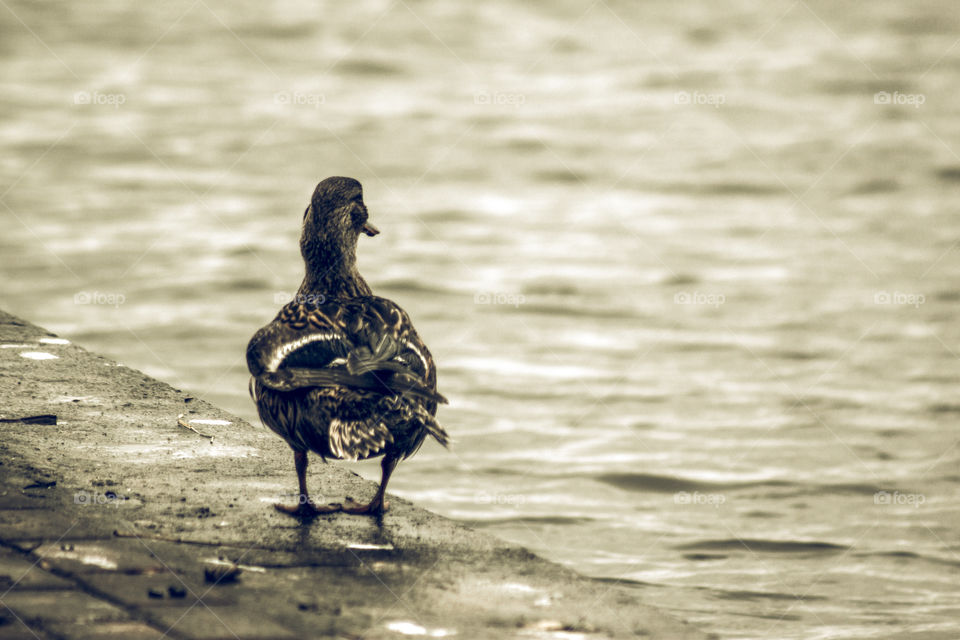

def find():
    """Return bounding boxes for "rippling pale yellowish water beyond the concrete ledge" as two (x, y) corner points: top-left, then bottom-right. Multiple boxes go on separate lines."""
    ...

(0, 0), (960, 638)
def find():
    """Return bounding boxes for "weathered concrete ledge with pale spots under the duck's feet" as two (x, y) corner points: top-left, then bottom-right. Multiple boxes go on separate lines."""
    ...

(0, 312), (705, 640)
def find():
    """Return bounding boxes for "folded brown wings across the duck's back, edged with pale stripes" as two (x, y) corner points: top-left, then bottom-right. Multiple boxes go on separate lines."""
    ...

(247, 296), (446, 403)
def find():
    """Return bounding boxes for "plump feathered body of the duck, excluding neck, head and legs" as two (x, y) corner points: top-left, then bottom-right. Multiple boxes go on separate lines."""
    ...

(247, 296), (447, 459)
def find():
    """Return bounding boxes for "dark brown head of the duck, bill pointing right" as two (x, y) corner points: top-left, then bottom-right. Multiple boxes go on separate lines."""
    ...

(300, 176), (380, 266)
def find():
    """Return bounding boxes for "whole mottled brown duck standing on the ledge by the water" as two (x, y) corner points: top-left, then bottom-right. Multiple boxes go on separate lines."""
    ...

(246, 176), (450, 517)
